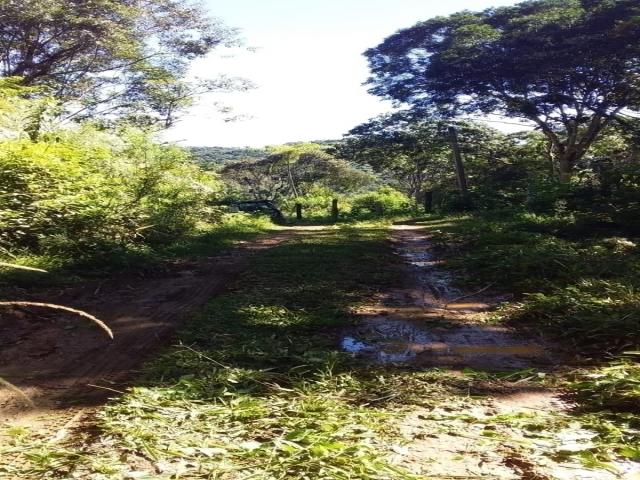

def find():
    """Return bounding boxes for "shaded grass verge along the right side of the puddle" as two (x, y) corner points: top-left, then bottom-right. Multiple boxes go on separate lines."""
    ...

(412, 212), (640, 465)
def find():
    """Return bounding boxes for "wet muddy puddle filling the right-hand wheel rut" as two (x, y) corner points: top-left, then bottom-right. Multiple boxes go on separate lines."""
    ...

(341, 226), (549, 370)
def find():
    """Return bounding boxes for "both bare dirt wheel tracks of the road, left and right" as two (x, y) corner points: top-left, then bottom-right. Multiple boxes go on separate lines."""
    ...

(0, 225), (638, 480)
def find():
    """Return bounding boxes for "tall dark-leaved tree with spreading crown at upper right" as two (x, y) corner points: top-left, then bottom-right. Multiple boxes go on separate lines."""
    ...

(365, 0), (640, 180)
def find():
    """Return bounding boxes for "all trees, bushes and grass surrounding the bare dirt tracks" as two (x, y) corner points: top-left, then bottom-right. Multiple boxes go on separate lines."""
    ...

(0, 0), (640, 479)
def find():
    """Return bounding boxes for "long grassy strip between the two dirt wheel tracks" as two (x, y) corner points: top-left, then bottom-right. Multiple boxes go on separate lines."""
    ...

(0, 227), (430, 479)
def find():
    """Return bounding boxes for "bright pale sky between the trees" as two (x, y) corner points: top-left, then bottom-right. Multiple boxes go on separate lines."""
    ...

(166, 0), (517, 146)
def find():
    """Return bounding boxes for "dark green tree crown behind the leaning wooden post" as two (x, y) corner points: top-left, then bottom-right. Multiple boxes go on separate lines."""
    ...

(339, 112), (515, 202)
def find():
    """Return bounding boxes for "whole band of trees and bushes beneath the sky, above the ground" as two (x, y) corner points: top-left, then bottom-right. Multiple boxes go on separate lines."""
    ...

(0, 0), (640, 262)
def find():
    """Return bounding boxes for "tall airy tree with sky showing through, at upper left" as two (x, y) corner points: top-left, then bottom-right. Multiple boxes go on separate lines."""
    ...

(0, 0), (245, 125)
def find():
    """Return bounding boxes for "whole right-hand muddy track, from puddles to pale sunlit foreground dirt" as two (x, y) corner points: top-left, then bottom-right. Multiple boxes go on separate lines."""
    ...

(341, 225), (640, 480)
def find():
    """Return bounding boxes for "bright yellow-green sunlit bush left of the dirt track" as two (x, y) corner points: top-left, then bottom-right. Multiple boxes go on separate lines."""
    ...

(0, 127), (219, 254)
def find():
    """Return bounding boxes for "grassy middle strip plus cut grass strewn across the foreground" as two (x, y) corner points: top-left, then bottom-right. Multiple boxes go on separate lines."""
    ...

(0, 219), (638, 480)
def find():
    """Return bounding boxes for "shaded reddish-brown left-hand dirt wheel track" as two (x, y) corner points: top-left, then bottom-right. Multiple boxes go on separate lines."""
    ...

(0, 229), (304, 438)
